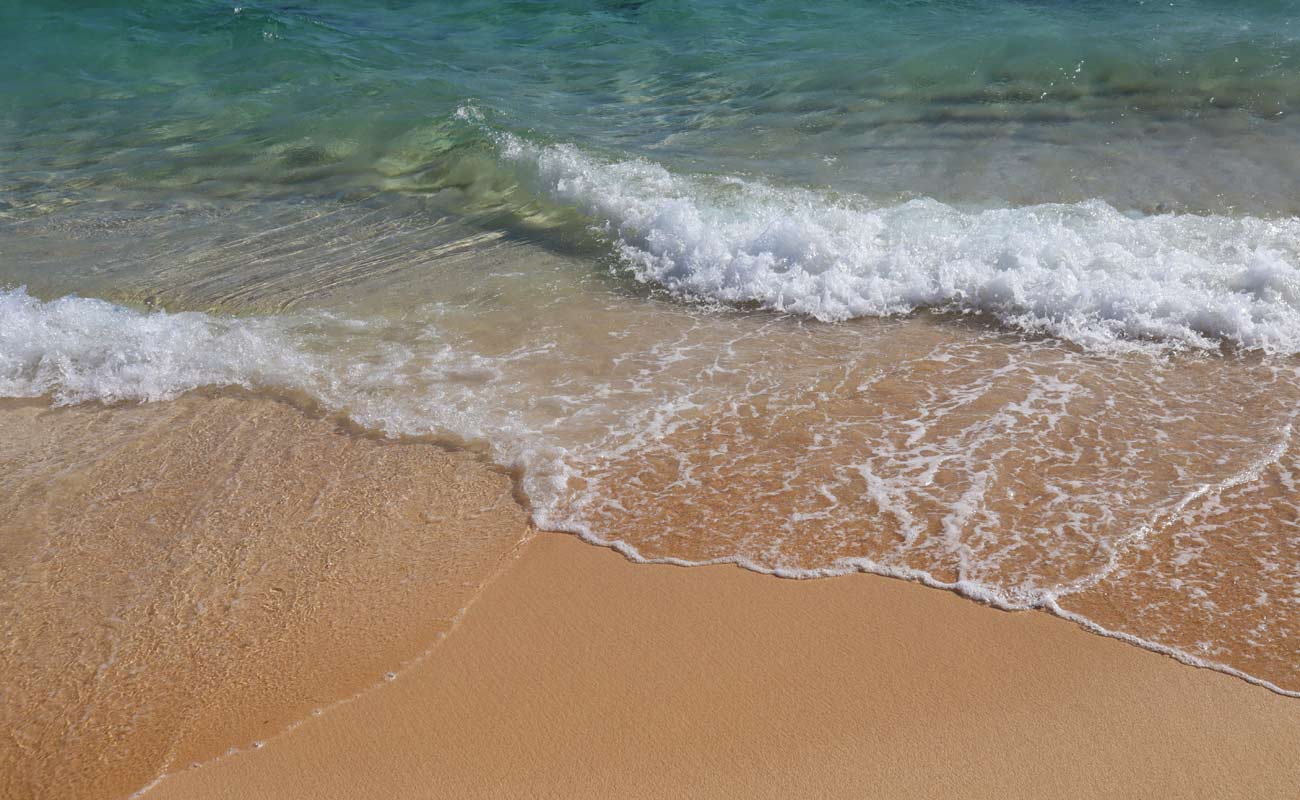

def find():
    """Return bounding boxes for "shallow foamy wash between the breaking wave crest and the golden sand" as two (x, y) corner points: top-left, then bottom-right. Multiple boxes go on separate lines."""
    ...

(0, 282), (1296, 691)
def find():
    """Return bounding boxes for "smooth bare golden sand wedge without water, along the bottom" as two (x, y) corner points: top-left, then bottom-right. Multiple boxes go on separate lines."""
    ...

(147, 533), (1300, 800)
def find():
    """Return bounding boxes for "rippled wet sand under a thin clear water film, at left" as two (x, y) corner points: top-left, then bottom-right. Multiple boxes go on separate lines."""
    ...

(0, 395), (528, 800)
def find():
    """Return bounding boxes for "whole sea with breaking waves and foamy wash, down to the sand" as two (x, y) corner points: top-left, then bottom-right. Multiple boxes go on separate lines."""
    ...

(0, 0), (1300, 693)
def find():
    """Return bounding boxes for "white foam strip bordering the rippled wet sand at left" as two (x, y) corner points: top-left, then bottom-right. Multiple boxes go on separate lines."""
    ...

(0, 287), (567, 512)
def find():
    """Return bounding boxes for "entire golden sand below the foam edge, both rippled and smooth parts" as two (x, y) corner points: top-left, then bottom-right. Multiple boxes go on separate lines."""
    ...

(0, 394), (1300, 800)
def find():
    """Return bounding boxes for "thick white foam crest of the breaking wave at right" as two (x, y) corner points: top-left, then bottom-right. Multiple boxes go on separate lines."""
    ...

(497, 134), (1300, 353)
